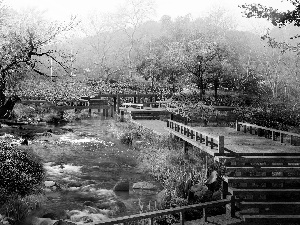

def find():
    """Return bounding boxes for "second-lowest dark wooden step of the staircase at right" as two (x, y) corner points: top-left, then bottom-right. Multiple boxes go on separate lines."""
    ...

(238, 202), (300, 215)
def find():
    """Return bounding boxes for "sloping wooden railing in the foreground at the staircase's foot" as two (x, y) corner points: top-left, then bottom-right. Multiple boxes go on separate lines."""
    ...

(95, 198), (235, 225)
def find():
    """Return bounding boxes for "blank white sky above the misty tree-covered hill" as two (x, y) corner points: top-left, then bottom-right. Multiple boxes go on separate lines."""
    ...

(5, 0), (292, 33)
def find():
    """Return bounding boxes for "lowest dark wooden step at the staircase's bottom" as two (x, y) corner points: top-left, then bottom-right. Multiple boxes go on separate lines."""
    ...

(242, 215), (300, 225)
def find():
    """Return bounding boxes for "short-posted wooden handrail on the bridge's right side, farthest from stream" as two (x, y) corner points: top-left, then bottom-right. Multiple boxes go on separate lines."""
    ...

(236, 121), (300, 145)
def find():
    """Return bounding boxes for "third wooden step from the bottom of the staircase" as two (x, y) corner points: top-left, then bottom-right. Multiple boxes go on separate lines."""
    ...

(228, 187), (300, 202)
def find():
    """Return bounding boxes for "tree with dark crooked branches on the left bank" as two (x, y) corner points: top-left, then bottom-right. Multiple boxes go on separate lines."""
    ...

(0, 5), (77, 105)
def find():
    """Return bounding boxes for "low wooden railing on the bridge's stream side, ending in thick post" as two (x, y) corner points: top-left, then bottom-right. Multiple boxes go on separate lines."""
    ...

(167, 119), (224, 154)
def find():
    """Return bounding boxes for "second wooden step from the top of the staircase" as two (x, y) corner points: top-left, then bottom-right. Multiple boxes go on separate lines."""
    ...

(225, 167), (300, 179)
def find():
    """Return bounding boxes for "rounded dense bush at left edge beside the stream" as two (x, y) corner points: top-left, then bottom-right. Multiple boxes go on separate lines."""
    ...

(0, 142), (45, 204)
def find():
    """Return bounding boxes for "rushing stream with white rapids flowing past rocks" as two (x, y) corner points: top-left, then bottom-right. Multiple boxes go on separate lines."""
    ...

(17, 119), (159, 222)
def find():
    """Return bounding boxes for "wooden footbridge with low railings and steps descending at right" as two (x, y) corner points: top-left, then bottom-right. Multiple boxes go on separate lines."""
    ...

(166, 120), (300, 223)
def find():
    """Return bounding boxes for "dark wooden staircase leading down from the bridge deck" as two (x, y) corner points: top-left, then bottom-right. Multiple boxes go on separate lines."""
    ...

(220, 154), (300, 224)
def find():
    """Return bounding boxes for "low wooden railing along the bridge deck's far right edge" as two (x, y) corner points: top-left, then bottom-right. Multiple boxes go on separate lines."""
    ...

(236, 121), (300, 145)
